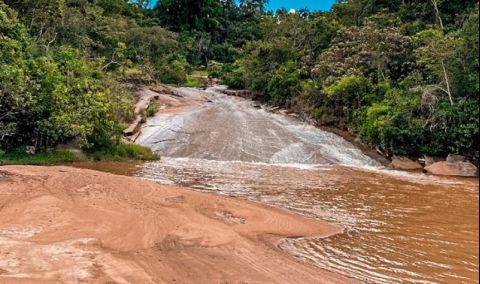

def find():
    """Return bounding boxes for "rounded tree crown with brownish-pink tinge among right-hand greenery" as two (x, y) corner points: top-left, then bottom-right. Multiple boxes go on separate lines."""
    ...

(313, 24), (414, 85)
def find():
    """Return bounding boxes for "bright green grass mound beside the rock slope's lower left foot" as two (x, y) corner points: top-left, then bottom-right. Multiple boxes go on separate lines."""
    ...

(87, 144), (159, 161)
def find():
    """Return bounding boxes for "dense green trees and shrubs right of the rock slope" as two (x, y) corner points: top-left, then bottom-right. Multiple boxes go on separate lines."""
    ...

(218, 0), (480, 164)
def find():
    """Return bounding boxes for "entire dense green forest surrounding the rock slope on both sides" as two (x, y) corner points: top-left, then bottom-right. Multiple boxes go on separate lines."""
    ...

(0, 0), (480, 164)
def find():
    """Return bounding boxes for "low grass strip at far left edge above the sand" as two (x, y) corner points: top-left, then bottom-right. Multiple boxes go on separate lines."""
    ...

(0, 148), (79, 165)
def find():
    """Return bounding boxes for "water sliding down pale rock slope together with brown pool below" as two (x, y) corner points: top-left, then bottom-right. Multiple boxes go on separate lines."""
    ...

(133, 89), (479, 283)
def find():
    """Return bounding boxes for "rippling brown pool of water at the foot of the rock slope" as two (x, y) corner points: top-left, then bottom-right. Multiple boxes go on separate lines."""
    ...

(140, 158), (479, 283)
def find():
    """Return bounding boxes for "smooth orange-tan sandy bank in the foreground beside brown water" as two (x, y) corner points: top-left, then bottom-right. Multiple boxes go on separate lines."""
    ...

(0, 167), (352, 283)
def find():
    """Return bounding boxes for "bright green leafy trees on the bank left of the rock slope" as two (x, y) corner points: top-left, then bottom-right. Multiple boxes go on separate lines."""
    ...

(0, 4), (135, 151)
